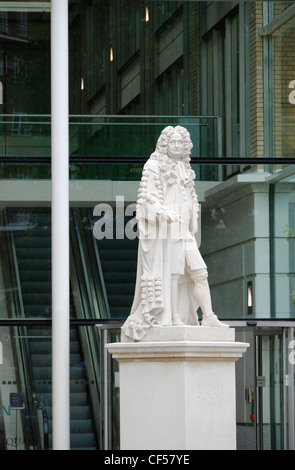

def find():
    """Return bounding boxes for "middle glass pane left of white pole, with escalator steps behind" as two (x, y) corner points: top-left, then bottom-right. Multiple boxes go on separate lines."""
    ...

(0, 208), (51, 318)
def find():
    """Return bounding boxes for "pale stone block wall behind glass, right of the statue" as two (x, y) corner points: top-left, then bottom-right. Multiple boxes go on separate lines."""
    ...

(201, 180), (270, 319)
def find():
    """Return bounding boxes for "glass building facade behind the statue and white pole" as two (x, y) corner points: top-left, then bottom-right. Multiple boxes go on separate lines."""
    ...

(0, 0), (295, 450)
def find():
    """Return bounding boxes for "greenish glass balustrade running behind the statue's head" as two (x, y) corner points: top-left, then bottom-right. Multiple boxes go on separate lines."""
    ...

(0, 114), (222, 162)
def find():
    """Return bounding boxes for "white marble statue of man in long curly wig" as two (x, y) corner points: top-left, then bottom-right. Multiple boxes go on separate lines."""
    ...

(122, 126), (228, 341)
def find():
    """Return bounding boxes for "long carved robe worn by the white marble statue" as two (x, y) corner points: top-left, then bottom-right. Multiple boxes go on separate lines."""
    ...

(122, 157), (206, 341)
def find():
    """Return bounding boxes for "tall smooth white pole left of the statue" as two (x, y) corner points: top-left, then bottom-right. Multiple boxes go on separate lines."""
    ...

(51, 0), (70, 450)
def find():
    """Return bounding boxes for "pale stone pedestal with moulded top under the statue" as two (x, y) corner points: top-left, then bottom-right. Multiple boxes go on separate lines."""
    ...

(106, 326), (249, 450)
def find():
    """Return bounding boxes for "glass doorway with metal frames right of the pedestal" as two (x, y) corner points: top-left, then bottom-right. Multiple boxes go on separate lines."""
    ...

(234, 320), (295, 450)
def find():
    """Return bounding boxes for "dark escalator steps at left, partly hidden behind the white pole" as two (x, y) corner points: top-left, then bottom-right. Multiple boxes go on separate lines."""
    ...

(8, 209), (98, 450)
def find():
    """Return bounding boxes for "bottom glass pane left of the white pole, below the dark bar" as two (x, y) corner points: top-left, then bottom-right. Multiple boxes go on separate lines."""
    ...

(0, 326), (51, 450)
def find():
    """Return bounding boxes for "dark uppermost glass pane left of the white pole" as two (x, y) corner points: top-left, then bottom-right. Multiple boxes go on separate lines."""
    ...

(0, 2), (50, 116)
